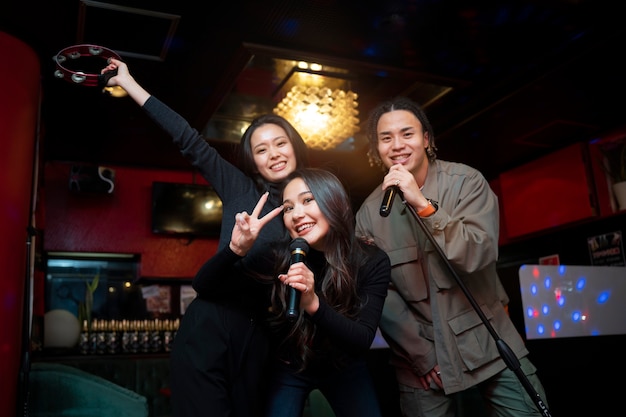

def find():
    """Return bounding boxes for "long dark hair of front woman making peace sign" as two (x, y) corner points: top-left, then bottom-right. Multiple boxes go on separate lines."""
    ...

(270, 168), (367, 370)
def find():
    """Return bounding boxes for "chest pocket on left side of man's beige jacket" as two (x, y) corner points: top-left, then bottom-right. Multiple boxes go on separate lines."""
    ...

(387, 246), (428, 301)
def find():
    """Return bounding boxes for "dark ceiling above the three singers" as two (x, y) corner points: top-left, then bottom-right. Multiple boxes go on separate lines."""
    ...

(0, 0), (626, 207)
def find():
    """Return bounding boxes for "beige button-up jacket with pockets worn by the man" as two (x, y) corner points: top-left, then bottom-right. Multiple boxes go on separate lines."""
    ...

(357, 160), (528, 394)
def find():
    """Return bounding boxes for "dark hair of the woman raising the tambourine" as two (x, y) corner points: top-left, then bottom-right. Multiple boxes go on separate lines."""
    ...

(237, 113), (309, 192)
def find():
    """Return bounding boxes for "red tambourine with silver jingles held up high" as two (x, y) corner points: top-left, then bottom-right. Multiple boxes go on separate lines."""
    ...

(54, 44), (121, 87)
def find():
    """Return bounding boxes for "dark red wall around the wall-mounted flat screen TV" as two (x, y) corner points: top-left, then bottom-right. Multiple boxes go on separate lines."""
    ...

(40, 162), (218, 278)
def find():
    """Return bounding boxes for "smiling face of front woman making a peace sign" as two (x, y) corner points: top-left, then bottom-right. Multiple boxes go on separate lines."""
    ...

(283, 178), (330, 251)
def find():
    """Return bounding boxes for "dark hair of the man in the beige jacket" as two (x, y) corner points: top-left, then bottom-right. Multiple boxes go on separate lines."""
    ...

(367, 96), (437, 172)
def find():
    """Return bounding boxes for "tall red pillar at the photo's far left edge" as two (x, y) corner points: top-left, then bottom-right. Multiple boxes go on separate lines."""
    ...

(0, 32), (41, 416)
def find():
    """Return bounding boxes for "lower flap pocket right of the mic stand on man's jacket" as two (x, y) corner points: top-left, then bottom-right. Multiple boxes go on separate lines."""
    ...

(448, 305), (500, 371)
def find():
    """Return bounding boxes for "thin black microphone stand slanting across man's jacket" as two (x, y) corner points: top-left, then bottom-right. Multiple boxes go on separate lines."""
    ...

(399, 191), (551, 417)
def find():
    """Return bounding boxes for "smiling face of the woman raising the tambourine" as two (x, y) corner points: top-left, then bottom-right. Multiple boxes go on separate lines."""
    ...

(250, 123), (296, 183)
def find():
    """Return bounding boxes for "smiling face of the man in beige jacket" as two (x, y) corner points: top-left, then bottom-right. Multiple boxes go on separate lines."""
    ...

(376, 110), (428, 177)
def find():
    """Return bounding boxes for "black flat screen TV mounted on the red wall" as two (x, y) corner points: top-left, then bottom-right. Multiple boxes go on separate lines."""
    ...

(152, 182), (222, 237)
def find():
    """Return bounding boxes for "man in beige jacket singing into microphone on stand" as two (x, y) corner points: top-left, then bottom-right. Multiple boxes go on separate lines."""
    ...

(357, 97), (547, 417)
